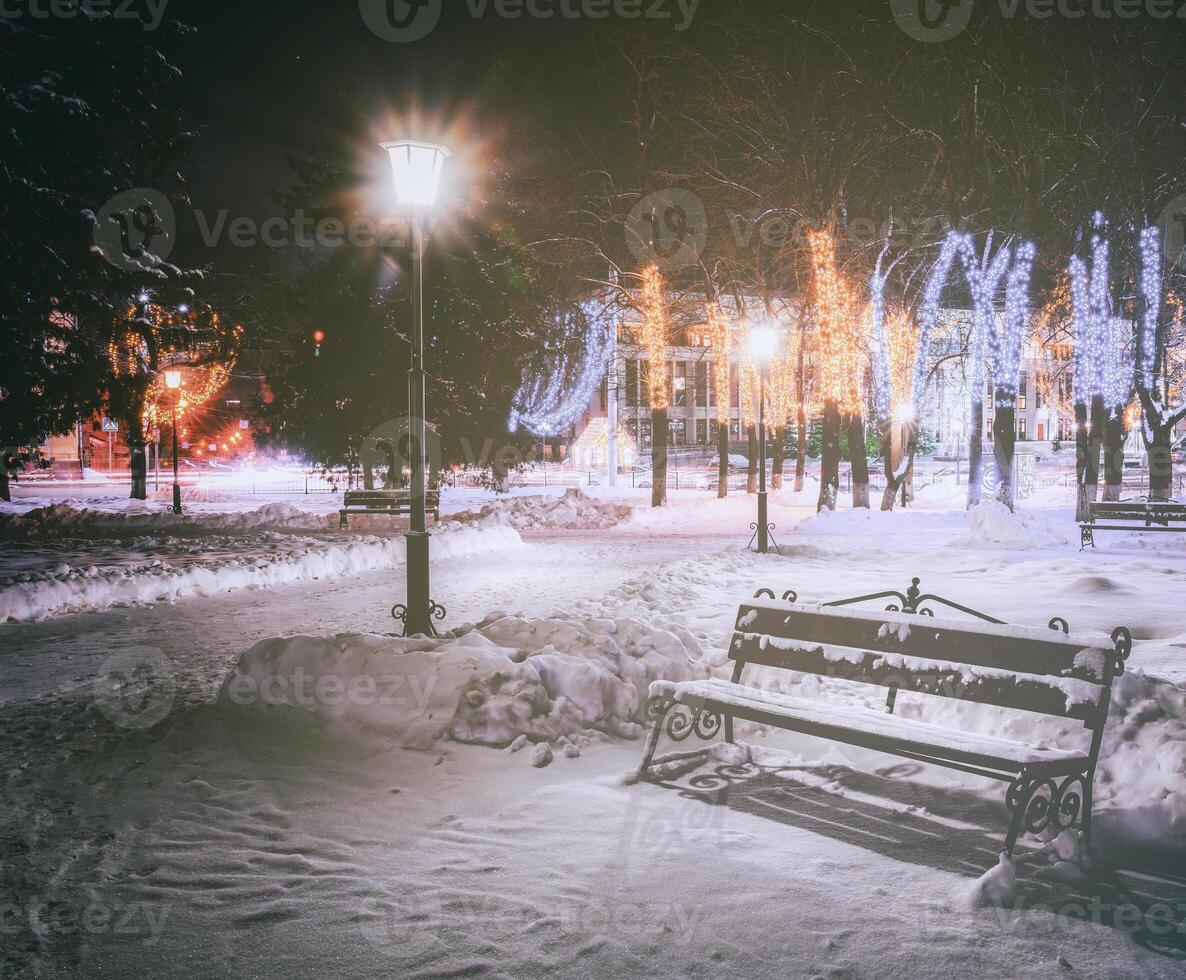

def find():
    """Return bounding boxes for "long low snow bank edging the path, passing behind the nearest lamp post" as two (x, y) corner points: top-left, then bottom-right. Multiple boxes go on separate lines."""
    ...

(0, 515), (523, 622)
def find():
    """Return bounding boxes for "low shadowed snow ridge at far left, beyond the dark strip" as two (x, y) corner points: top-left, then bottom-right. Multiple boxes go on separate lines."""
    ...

(0, 500), (326, 537)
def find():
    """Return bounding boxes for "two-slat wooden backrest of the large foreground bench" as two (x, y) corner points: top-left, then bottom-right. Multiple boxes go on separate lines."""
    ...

(729, 598), (1122, 730)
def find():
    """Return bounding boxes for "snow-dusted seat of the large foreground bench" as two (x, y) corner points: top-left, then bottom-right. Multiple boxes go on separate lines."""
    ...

(650, 680), (1086, 772)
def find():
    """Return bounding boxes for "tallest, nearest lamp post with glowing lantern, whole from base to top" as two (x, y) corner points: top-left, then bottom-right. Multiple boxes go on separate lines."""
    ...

(381, 140), (449, 636)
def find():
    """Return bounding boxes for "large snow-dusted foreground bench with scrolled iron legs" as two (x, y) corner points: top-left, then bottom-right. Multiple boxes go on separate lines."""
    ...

(638, 579), (1133, 853)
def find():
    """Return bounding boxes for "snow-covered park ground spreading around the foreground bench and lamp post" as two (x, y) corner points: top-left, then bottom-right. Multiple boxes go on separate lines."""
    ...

(0, 476), (1186, 976)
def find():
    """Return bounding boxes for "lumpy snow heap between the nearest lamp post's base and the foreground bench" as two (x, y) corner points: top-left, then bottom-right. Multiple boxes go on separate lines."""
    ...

(218, 616), (707, 758)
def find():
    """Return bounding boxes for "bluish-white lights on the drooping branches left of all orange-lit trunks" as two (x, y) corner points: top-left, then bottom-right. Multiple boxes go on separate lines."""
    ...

(506, 300), (616, 438)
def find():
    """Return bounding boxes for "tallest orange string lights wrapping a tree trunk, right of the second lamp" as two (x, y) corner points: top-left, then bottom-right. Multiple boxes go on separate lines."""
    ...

(808, 229), (865, 414)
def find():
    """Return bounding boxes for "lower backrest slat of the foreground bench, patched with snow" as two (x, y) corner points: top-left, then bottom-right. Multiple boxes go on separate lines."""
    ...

(731, 634), (1105, 723)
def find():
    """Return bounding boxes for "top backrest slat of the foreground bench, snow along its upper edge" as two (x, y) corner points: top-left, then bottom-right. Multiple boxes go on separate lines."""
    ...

(729, 599), (1111, 679)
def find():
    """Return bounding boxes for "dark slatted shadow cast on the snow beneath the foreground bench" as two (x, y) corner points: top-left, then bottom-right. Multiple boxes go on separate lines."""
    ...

(658, 762), (1186, 960)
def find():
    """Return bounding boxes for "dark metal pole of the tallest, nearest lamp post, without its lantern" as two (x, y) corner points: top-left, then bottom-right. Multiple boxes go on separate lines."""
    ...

(403, 216), (434, 636)
